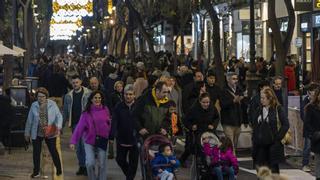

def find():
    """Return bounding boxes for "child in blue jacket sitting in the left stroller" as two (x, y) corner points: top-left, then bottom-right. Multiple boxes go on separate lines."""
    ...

(151, 144), (180, 180)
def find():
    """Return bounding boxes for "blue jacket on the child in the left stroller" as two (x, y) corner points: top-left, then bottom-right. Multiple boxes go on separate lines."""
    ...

(151, 153), (180, 176)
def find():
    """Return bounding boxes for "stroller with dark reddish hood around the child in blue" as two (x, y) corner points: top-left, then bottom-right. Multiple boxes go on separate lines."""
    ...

(138, 135), (173, 180)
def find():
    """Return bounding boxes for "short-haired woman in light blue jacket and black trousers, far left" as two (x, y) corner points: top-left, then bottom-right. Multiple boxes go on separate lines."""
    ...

(24, 87), (62, 178)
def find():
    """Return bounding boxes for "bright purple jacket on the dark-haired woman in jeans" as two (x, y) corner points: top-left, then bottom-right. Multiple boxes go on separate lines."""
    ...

(70, 105), (111, 145)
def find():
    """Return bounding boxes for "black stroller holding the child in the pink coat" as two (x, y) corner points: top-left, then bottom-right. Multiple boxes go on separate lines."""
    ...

(191, 131), (220, 180)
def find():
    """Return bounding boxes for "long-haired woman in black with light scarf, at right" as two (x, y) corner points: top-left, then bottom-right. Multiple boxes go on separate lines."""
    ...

(252, 88), (289, 173)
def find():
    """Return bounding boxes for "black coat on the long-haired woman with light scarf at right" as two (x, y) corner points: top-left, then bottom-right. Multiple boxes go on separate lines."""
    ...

(252, 106), (289, 164)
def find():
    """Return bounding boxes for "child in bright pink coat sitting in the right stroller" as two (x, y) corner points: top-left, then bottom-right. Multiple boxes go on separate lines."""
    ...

(202, 137), (239, 180)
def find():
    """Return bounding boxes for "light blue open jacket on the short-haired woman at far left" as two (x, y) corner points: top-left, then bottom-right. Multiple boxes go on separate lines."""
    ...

(24, 99), (62, 140)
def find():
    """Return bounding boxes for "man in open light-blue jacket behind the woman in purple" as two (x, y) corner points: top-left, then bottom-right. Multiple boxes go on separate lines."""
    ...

(63, 76), (91, 175)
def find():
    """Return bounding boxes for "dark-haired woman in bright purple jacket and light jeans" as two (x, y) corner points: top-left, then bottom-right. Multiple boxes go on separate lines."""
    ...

(70, 91), (111, 180)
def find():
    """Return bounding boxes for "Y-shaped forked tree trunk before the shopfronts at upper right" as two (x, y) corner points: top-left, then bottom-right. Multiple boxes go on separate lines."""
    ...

(268, 0), (295, 77)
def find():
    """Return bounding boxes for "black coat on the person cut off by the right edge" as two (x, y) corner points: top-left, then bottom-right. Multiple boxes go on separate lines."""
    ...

(304, 104), (320, 154)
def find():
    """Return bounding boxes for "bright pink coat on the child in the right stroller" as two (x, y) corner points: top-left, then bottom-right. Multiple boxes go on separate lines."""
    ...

(203, 143), (239, 174)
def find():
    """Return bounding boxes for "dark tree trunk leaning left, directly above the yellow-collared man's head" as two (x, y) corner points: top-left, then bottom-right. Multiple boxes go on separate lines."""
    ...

(125, 0), (159, 66)
